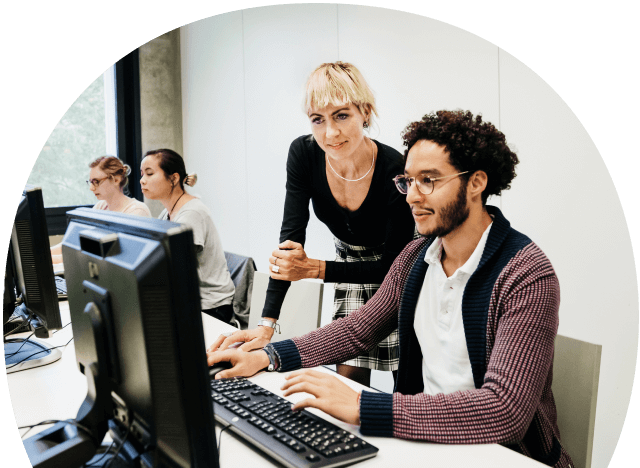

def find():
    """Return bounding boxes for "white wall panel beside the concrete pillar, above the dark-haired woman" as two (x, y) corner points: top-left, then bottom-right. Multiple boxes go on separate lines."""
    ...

(180, 12), (251, 255)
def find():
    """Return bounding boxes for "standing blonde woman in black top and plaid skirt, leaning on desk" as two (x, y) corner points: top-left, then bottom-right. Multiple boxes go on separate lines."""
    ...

(209, 62), (415, 386)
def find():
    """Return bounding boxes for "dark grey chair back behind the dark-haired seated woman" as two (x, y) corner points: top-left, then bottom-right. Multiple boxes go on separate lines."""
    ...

(224, 252), (256, 330)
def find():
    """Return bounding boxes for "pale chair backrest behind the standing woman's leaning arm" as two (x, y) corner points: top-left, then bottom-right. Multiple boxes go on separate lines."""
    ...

(249, 271), (324, 342)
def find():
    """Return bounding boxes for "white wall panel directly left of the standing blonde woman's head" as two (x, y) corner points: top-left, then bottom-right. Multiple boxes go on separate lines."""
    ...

(243, 4), (337, 278)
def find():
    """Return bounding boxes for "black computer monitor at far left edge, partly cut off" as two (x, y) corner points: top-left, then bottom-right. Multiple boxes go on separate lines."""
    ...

(2, 185), (62, 373)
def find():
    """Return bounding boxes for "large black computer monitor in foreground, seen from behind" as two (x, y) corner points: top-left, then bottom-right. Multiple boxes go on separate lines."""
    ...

(24, 208), (218, 468)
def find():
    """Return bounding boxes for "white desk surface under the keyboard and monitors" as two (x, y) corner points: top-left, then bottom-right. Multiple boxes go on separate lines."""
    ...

(7, 302), (544, 468)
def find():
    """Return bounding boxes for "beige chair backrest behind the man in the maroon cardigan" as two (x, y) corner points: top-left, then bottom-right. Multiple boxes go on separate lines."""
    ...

(551, 335), (602, 468)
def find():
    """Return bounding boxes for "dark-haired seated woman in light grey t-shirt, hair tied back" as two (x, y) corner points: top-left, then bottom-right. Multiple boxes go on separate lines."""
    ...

(140, 149), (235, 323)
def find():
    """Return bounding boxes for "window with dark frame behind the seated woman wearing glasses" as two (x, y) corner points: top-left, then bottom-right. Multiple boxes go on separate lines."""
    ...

(27, 49), (143, 236)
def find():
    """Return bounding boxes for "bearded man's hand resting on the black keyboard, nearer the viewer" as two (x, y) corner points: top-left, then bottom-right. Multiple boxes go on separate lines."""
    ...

(280, 370), (360, 425)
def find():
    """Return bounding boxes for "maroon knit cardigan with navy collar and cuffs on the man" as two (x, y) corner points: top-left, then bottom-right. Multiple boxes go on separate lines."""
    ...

(273, 206), (572, 468)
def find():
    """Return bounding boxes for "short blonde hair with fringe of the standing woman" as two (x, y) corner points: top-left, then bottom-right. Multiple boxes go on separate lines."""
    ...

(304, 62), (378, 127)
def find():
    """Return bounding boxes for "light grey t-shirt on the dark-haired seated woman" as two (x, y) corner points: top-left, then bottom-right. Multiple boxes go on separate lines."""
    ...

(159, 198), (235, 310)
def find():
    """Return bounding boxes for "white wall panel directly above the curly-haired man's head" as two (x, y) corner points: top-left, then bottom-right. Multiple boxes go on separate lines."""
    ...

(339, 5), (499, 152)
